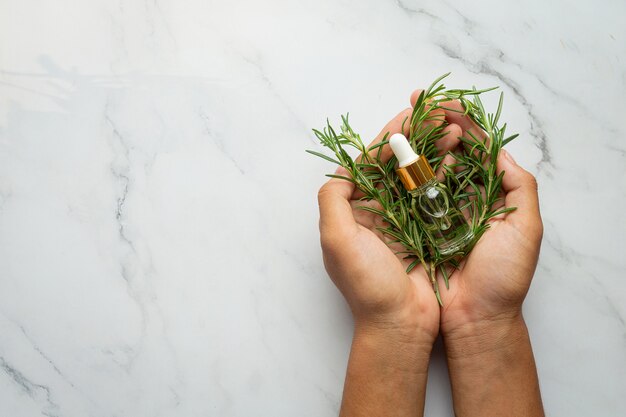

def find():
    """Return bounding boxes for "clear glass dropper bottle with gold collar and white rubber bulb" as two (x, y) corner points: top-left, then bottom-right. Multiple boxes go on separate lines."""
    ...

(389, 133), (473, 255)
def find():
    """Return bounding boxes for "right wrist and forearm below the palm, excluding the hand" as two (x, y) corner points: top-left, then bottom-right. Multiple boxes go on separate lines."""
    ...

(443, 314), (544, 416)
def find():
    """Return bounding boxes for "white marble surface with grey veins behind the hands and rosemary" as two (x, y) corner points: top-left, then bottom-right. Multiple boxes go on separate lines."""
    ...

(0, 0), (626, 417)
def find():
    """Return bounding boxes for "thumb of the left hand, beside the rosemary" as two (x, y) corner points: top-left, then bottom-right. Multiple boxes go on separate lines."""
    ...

(317, 167), (358, 244)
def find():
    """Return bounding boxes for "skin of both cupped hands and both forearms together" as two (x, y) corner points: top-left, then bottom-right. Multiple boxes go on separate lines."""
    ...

(318, 92), (543, 416)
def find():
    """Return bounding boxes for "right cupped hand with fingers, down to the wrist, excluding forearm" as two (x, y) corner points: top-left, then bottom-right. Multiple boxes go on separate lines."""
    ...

(404, 90), (543, 336)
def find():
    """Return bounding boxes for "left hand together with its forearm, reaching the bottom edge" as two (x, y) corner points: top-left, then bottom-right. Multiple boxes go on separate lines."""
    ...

(319, 109), (460, 417)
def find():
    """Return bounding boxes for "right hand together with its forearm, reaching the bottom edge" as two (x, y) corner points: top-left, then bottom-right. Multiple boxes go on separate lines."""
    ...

(412, 91), (544, 417)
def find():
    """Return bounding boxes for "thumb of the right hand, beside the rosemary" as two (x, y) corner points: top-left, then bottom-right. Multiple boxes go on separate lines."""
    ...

(497, 149), (543, 240)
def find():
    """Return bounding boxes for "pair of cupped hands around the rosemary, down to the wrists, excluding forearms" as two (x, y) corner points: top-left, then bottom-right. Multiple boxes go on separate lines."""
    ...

(318, 90), (543, 339)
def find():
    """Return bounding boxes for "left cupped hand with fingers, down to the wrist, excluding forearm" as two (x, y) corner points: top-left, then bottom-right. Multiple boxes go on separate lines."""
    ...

(318, 108), (460, 342)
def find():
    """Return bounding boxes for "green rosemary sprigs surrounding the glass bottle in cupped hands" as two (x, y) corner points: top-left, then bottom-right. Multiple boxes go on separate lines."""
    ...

(307, 73), (517, 304)
